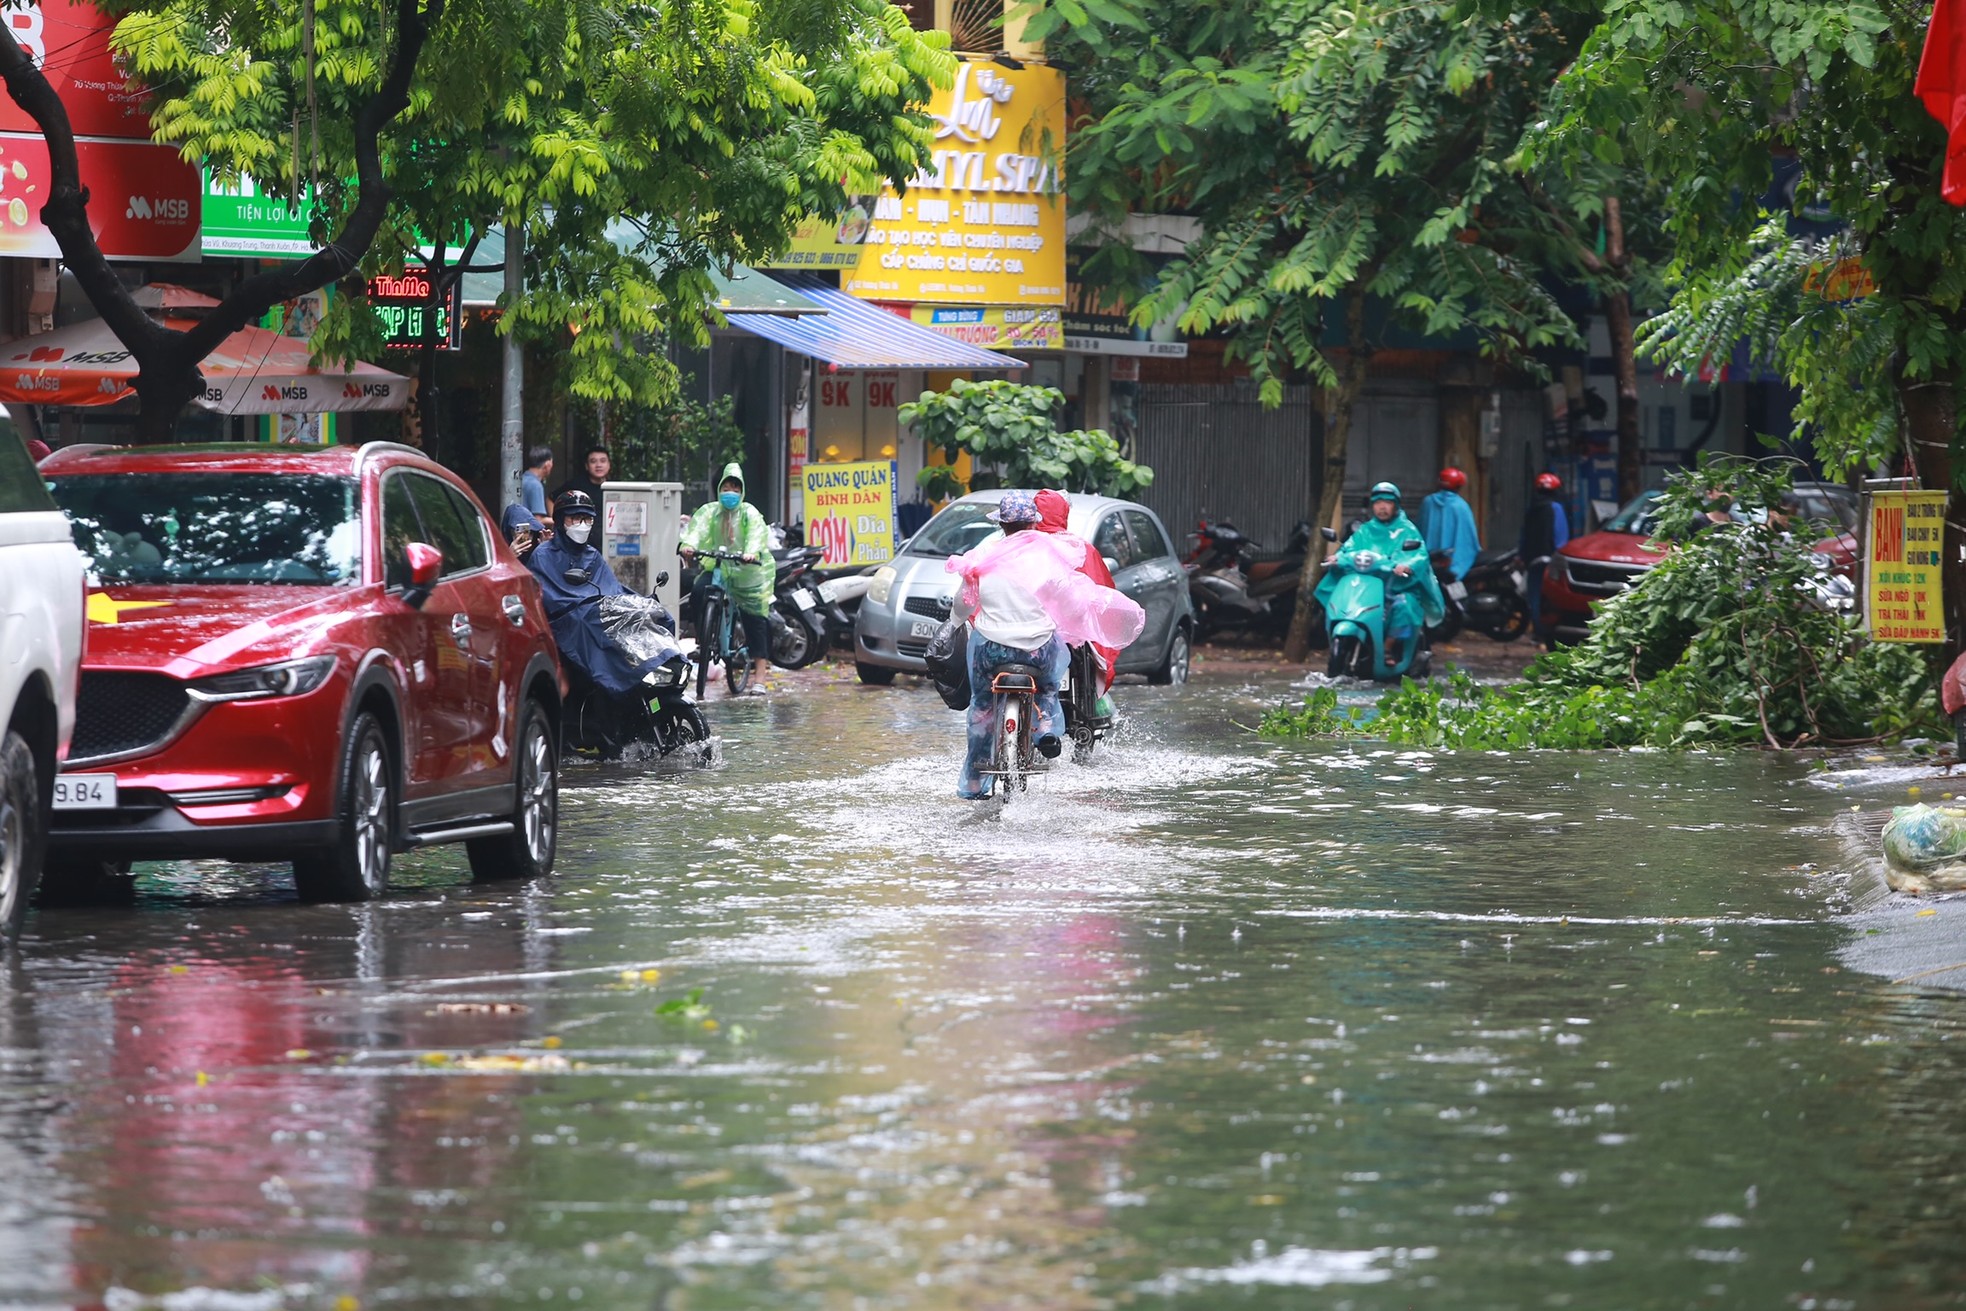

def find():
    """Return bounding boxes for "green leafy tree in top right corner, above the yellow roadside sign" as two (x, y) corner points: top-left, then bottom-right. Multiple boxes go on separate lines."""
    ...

(1530, 0), (1966, 651)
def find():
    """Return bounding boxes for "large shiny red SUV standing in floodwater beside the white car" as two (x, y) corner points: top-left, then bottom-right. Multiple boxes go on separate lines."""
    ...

(41, 444), (560, 902)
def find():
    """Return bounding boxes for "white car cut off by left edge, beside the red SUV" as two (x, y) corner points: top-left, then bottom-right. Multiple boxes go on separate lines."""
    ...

(0, 430), (85, 938)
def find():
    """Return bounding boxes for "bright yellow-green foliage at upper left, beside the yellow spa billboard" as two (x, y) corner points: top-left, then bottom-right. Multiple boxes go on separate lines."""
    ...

(116, 0), (954, 405)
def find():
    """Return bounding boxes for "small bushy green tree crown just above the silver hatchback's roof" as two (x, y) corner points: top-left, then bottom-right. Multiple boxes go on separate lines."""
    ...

(898, 377), (1154, 501)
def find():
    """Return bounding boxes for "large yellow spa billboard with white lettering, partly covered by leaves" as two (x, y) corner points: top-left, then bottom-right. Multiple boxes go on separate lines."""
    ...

(761, 61), (1066, 305)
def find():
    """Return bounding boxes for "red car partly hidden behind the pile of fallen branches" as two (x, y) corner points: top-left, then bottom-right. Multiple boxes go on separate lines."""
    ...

(1541, 482), (1856, 643)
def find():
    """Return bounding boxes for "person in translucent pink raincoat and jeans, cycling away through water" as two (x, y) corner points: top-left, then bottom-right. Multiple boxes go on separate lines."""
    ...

(944, 491), (1146, 800)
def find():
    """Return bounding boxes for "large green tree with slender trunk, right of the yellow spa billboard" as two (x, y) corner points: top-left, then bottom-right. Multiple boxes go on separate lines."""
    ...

(1026, 0), (1638, 658)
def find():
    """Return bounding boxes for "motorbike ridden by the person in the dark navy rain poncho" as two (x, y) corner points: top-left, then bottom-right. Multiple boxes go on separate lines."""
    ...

(560, 574), (710, 761)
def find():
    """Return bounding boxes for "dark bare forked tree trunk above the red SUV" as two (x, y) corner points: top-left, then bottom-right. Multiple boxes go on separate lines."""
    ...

(0, 0), (444, 444)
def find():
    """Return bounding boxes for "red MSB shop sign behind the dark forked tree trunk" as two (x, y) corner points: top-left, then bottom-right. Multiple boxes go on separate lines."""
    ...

(0, 132), (204, 263)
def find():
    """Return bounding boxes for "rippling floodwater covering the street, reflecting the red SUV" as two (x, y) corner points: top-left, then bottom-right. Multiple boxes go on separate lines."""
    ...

(0, 678), (1966, 1311)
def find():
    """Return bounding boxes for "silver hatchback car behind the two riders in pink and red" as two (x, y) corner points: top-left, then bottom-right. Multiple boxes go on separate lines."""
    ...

(853, 491), (1195, 684)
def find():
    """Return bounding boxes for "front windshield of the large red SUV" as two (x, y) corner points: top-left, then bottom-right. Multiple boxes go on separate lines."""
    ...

(49, 472), (362, 584)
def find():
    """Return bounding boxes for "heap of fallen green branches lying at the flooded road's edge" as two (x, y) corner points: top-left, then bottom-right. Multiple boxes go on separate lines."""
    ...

(1262, 460), (1944, 751)
